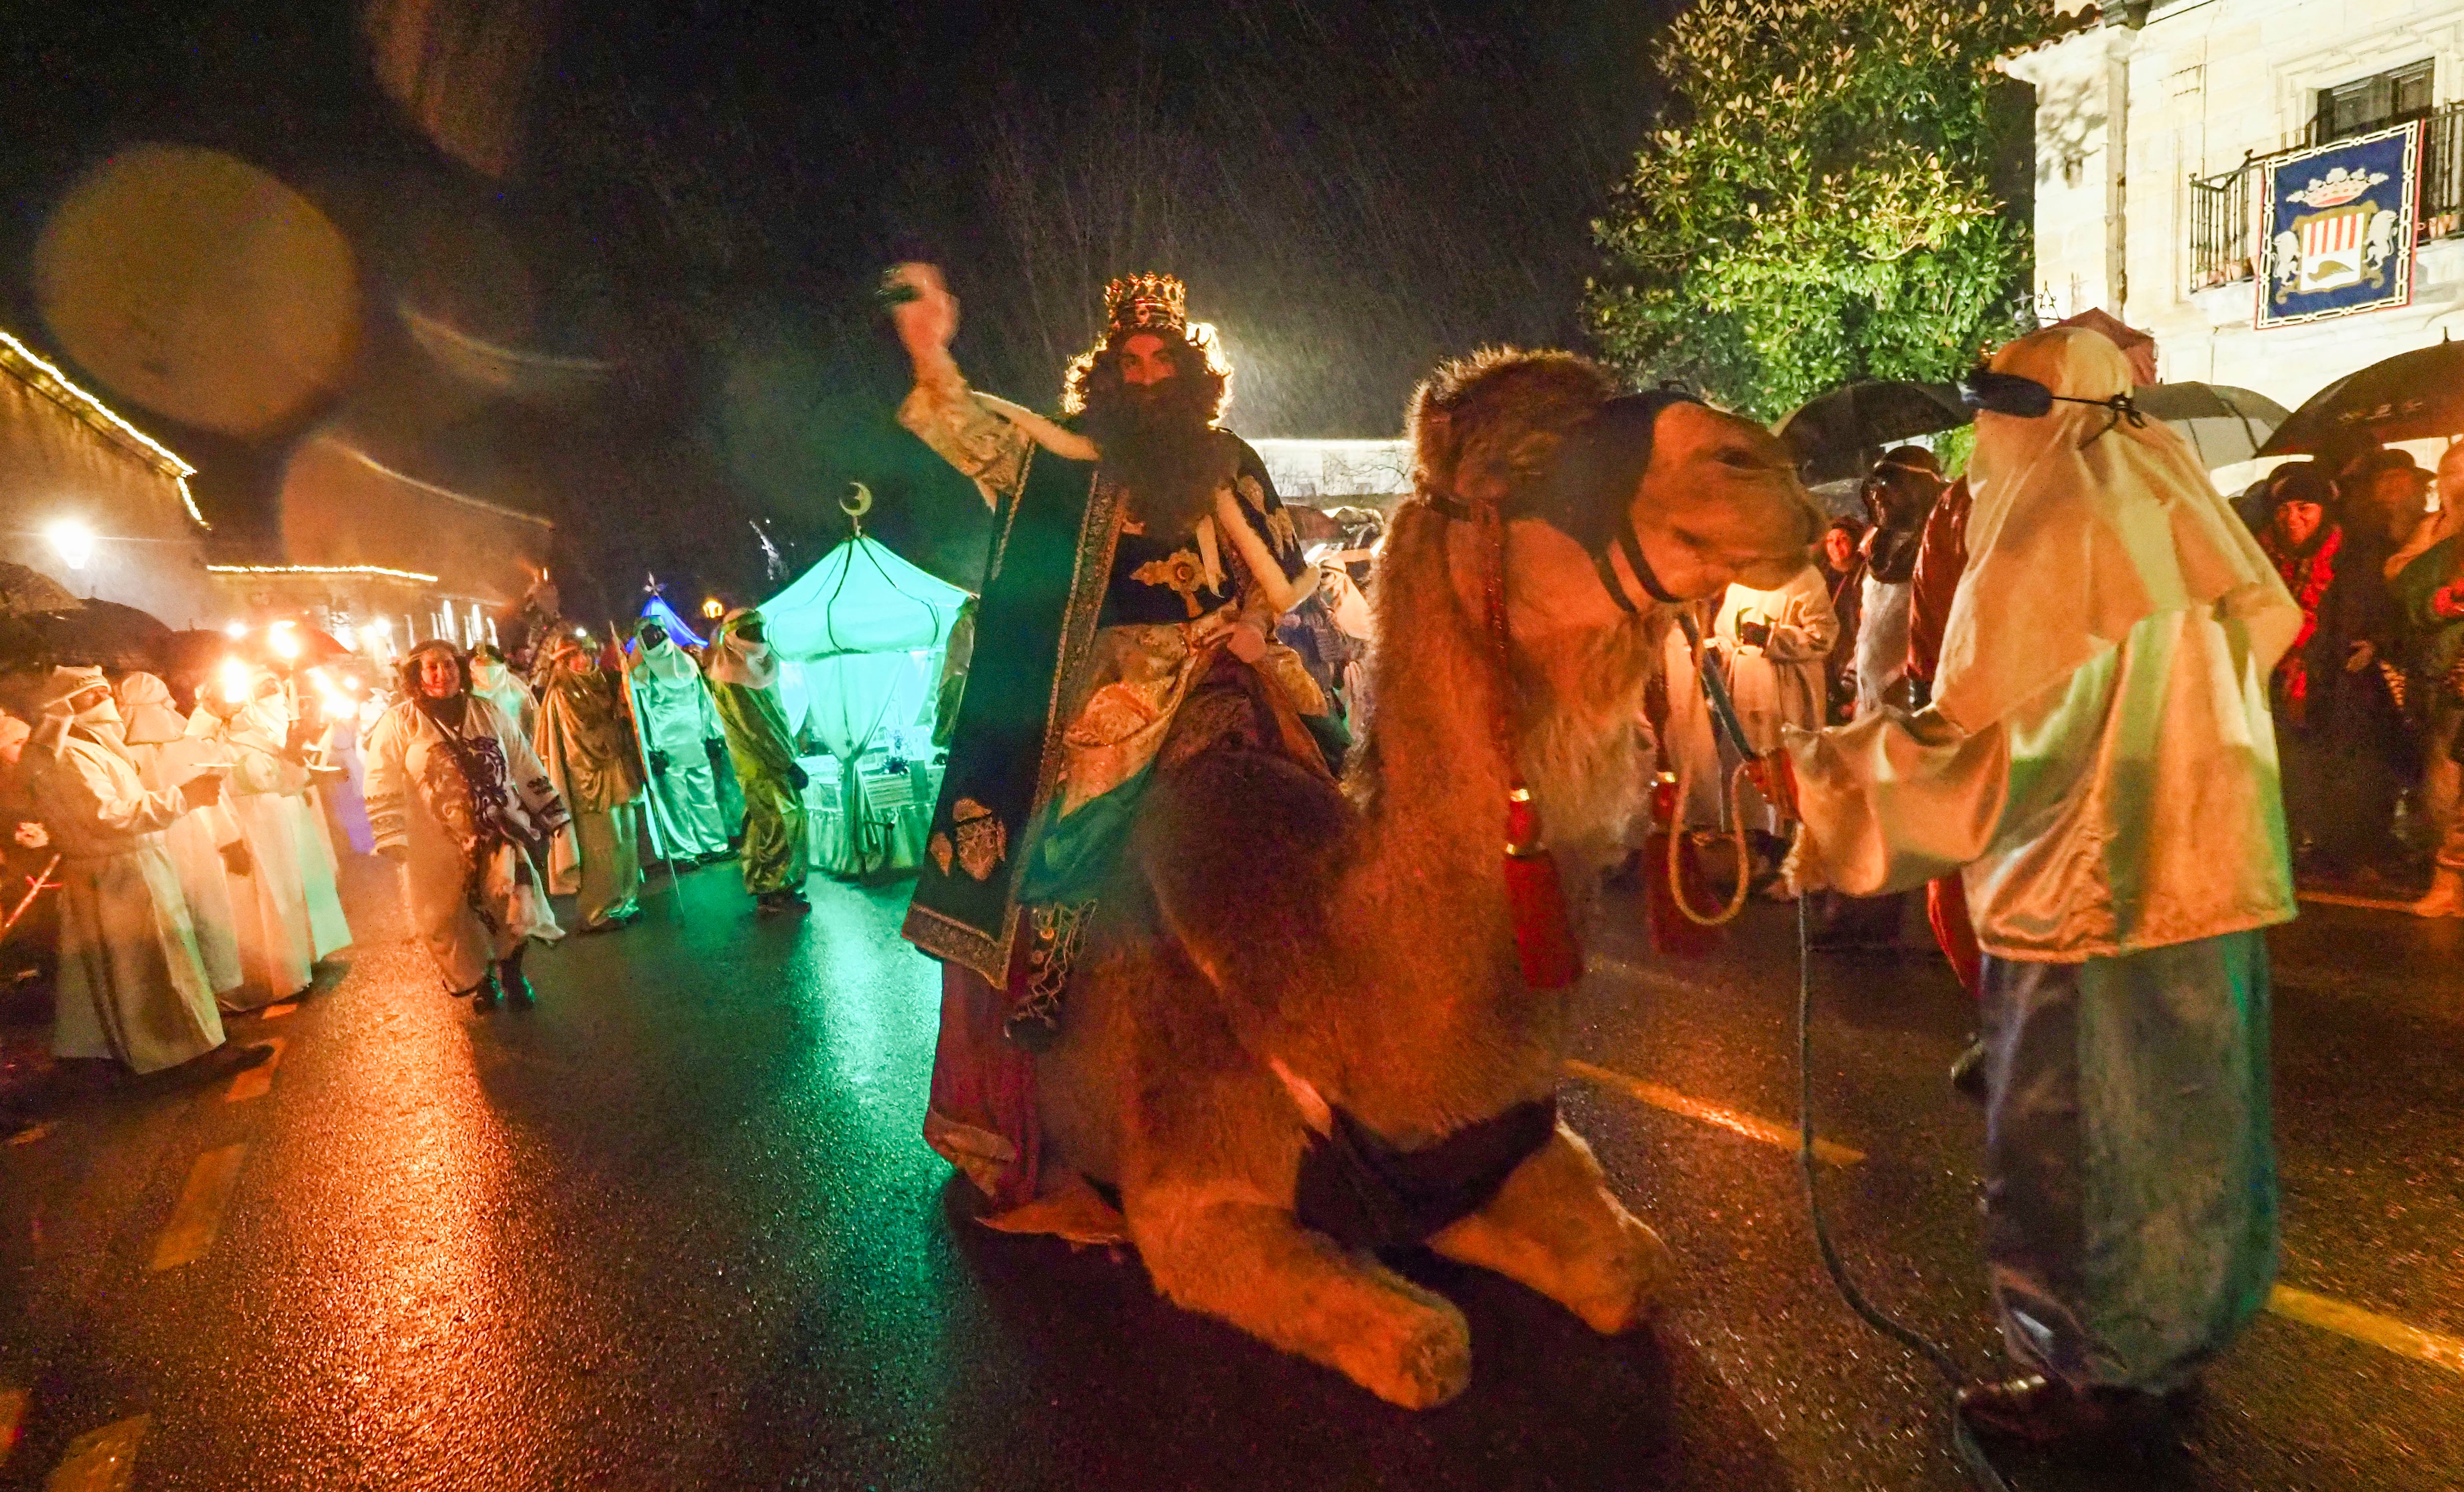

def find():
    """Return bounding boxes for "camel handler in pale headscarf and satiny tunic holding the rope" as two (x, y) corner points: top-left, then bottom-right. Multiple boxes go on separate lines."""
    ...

(1759, 328), (2302, 1443)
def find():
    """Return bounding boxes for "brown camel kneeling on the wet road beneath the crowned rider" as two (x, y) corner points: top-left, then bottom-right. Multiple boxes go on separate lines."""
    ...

(1037, 350), (1819, 1408)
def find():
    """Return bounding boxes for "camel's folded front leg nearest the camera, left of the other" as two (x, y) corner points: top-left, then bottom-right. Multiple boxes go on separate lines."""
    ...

(1126, 1189), (1471, 1408)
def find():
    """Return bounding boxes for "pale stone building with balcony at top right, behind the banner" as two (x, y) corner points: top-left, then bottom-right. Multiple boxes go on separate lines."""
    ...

(2003, 0), (2464, 409)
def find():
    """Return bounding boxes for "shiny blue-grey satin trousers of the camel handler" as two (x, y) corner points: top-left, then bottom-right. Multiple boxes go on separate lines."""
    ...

(1979, 932), (2277, 1393)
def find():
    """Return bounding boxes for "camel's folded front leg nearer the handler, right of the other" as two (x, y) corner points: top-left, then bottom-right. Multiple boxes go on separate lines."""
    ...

(1429, 1122), (1676, 1334)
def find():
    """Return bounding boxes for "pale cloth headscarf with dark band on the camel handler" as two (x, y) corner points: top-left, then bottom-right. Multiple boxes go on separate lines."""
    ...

(1934, 328), (2302, 735)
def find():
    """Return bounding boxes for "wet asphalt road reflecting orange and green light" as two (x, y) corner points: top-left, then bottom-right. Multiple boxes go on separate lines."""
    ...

(0, 848), (2464, 1492)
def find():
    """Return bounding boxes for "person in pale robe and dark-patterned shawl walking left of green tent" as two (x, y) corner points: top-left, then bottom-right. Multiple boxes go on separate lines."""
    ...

(367, 641), (569, 1008)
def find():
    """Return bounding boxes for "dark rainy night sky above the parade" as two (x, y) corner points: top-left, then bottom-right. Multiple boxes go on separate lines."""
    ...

(0, 0), (1678, 612)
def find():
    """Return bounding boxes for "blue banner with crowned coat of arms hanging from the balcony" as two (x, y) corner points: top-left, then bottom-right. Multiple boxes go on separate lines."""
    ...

(2257, 121), (2422, 330)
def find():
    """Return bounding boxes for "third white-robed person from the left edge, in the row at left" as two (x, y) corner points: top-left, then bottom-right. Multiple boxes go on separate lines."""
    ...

(187, 661), (316, 1011)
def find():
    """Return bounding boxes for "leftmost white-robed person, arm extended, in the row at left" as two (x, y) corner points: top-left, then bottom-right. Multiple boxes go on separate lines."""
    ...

(20, 668), (240, 1073)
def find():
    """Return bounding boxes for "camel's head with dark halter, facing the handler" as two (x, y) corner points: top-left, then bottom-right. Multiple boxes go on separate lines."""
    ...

(1412, 350), (1823, 626)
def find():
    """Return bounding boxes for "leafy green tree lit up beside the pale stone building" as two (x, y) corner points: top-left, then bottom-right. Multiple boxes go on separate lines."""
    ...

(1584, 0), (2058, 419)
